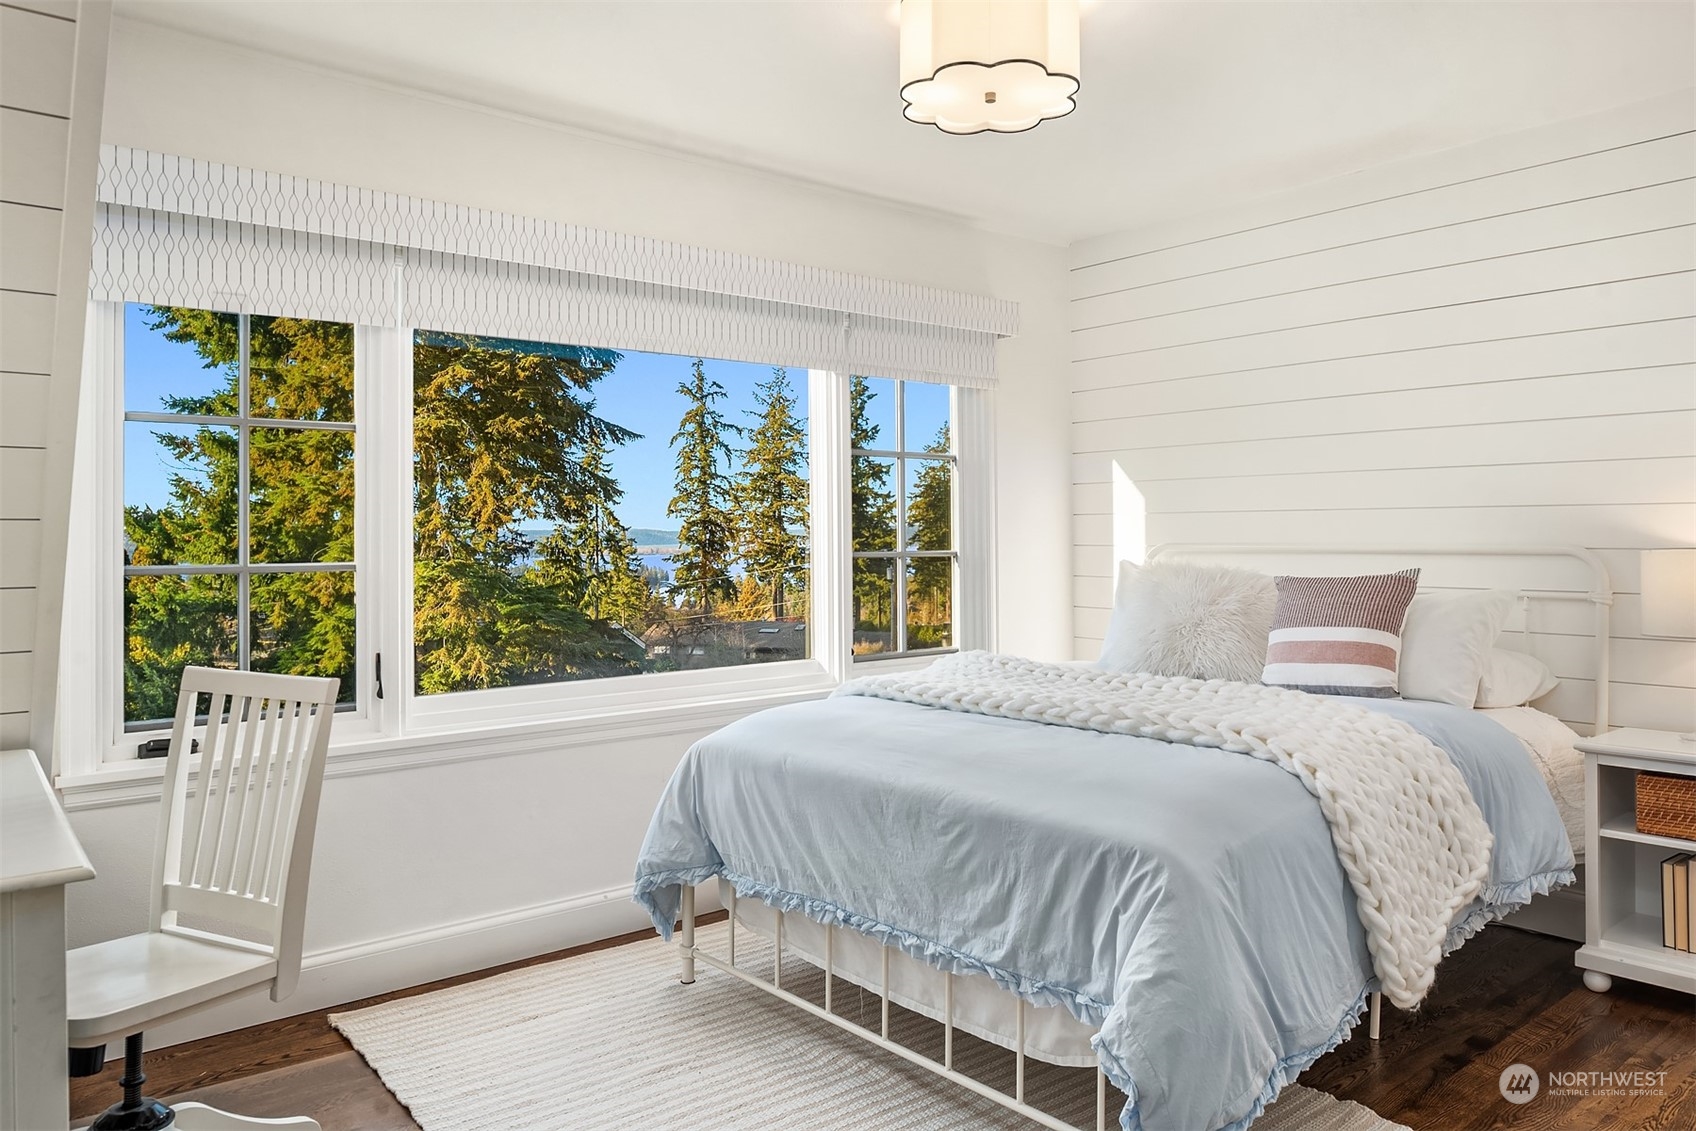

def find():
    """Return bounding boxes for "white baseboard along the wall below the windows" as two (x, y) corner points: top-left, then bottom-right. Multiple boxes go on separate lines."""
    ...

(121, 885), (717, 1060)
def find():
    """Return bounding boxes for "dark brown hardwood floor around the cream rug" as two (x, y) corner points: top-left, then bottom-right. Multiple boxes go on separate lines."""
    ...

(71, 912), (1696, 1131)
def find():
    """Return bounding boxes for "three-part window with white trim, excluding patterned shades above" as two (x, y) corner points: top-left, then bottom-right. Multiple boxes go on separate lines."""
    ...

(79, 304), (990, 770)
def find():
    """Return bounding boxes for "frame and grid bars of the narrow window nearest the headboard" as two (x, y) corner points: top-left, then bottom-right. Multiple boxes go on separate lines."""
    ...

(848, 373), (960, 663)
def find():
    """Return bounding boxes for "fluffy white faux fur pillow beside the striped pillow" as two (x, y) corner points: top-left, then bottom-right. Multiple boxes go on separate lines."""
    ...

(1101, 561), (1277, 683)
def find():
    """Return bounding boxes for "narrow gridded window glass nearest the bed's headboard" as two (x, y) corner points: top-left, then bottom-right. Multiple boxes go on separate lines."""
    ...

(848, 376), (957, 658)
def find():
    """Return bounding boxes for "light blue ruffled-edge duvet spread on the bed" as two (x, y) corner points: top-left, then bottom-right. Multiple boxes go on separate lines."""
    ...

(636, 697), (1572, 1131)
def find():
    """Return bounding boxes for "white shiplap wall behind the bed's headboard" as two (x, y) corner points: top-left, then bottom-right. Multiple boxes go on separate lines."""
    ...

(1070, 92), (1696, 729)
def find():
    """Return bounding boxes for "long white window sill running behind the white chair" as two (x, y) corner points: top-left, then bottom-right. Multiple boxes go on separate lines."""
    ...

(54, 677), (836, 812)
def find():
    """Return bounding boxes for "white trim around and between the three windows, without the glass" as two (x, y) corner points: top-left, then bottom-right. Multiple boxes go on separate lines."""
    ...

(59, 302), (994, 793)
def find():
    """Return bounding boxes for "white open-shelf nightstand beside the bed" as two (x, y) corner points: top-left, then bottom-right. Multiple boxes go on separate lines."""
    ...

(1576, 731), (1696, 994)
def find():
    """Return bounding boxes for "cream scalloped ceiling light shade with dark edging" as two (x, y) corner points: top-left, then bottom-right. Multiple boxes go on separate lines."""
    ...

(901, 0), (1079, 134)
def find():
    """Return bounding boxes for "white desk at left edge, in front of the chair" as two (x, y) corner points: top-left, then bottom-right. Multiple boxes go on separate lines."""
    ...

(0, 749), (95, 1131)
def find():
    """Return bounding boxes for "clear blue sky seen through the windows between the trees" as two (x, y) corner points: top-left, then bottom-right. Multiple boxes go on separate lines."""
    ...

(124, 305), (948, 529)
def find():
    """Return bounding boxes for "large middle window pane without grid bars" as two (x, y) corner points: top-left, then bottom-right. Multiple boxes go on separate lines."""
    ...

(412, 331), (811, 695)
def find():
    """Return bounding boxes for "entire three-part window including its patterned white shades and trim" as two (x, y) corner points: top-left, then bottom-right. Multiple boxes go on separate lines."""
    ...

(66, 146), (1018, 780)
